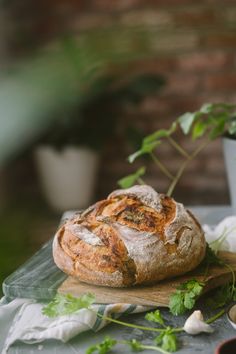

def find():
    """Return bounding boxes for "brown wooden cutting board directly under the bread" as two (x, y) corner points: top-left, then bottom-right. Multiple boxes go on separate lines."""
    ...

(58, 252), (236, 307)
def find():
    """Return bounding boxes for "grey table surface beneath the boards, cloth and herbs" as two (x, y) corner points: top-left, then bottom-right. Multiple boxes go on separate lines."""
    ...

(0, 206), (236, 354)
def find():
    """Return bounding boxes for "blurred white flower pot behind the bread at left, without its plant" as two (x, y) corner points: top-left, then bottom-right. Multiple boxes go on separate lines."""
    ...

(35, 146), (98, 212)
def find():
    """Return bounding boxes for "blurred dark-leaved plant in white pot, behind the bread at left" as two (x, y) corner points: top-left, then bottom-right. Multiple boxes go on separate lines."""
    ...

(35, 70), (163, 212)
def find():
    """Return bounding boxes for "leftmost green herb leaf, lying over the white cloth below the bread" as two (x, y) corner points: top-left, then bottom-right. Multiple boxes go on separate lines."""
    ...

(42, 294), (95, 317)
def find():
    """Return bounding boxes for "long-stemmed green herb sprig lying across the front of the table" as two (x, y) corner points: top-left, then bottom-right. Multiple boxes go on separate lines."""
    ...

(42, 285), (224, 354)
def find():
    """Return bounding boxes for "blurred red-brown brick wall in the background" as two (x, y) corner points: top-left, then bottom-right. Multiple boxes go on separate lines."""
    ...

(6, 0), (236, 204)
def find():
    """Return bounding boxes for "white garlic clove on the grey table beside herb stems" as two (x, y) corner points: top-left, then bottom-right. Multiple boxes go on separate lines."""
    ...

(183, 310), (214, 335)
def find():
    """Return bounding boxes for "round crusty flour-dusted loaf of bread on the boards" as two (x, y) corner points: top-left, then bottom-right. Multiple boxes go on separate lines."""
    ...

(53, 185), (206, 287)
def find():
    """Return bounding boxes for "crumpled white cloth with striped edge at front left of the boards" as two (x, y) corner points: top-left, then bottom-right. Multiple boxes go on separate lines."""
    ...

(0, 299), (150, 354)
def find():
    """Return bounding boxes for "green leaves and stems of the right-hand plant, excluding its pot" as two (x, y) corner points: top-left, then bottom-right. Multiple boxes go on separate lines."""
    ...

(118, 103), (236, 196)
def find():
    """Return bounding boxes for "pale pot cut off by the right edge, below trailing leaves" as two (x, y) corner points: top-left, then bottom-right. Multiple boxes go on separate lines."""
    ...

(223, 137), (236, 215)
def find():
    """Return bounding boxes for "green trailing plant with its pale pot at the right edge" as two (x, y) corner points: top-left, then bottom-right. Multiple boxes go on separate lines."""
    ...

(118, 103), (236, 213)
